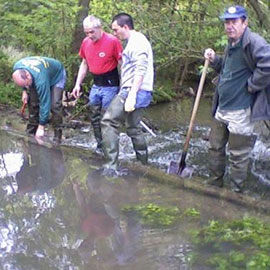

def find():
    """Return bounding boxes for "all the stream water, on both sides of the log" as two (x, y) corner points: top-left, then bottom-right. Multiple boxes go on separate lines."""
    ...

(0, 100), (270, 270)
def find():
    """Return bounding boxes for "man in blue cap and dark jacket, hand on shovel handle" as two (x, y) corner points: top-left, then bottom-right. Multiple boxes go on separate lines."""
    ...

(204, 6), (270, 192)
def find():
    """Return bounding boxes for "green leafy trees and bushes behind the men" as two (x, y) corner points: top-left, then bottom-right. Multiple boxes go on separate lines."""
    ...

(0, 0), (270, 107)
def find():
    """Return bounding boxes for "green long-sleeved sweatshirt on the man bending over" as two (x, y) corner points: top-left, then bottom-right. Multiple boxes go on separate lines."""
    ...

(13, 56), (64, 125)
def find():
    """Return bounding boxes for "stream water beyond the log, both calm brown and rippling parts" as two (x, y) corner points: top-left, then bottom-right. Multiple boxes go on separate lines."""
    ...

(62, 98), (270, 198)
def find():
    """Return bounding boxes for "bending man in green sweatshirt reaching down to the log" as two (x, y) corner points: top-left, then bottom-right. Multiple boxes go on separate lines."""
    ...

(12, 56), (66, 143)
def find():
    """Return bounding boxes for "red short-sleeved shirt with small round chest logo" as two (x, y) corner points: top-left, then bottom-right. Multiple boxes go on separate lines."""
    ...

(79, 32), (123, 75)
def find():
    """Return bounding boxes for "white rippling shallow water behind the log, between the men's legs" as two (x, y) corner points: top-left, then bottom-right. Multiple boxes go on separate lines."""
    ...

(63, 122), (270, 192)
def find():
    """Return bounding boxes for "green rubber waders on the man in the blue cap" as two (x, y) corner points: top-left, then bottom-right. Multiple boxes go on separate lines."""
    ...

(208, 119), (256, 192)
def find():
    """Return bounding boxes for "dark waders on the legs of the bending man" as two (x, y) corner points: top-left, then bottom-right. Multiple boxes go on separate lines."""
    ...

(26, 87), (63, 142)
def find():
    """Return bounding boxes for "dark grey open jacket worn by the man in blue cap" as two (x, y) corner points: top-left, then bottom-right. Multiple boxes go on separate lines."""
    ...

(211, 27), (270, 121)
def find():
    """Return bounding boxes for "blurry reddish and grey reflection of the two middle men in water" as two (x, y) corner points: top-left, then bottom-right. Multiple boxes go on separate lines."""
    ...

(73, 170), (141, 269)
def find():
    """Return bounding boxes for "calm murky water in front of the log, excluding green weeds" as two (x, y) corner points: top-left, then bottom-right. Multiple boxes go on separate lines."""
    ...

(0, 131), (269, 270)
